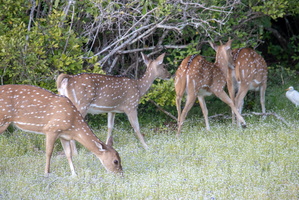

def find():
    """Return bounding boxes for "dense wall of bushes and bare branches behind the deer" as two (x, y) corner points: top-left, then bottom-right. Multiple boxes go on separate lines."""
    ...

(0, 0), (299, 106)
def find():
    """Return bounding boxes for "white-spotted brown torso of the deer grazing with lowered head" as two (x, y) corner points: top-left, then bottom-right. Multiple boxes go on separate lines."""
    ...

(0, 85), (89, 133)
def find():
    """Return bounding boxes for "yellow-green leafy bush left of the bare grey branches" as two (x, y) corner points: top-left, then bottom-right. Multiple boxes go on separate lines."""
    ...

(0, 1), (100, 91)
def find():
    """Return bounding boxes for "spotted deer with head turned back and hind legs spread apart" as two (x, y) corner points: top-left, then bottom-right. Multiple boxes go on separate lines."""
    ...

(175, 40), (246, 136)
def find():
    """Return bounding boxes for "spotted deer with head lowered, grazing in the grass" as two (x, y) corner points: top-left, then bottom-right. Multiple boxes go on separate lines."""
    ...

(0, 85), (122, 177)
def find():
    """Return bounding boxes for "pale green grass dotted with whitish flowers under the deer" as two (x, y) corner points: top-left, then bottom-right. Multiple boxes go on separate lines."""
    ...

(0, 111), (299, 199)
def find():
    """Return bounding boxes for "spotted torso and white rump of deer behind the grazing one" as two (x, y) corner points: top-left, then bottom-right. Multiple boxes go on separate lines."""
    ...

(57, 73), (140, 116)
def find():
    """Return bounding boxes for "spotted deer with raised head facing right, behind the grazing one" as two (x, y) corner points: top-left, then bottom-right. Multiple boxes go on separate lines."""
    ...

(56, 53), (170, 149)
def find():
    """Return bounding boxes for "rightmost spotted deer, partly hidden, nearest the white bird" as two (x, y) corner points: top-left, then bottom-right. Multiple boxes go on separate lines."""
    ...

(211, 44), (268, 124)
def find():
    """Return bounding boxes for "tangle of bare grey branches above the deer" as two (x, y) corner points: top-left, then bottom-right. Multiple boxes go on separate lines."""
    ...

(77, 0), (264, 74)
